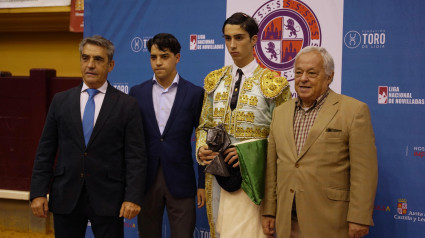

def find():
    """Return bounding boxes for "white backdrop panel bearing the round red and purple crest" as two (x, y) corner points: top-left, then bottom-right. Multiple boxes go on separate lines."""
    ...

(225, 0), (344, 96)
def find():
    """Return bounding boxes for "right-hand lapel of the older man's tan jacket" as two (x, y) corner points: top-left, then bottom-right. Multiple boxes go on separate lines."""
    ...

(298, 90), (339, 159)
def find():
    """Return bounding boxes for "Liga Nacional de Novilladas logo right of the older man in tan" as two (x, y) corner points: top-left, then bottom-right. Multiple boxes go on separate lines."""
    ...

(378, 86), (425, 105)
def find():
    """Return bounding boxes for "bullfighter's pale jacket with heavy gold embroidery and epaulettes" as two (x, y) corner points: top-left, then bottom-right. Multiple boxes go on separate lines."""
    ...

(196, 66), (291, 238)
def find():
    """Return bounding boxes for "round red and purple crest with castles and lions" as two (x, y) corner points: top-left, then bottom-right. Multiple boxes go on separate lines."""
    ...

(253, 0), (322, 81)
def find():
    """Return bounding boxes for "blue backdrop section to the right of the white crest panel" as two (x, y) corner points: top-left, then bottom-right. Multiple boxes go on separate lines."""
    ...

(342, 0), (425, 237)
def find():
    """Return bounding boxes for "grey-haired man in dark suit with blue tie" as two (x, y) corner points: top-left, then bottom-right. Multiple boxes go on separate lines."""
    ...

(30, 36), (146, 238)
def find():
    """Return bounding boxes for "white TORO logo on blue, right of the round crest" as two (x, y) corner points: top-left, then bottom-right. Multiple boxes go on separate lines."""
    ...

(344, 29), (387, 49)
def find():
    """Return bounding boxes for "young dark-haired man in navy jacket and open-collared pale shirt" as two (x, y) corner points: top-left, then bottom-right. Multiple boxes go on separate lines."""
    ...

(130, 33), (205, 238)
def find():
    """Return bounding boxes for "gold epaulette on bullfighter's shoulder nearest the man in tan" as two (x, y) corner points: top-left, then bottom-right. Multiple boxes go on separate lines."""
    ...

(260, 69), (289, 99)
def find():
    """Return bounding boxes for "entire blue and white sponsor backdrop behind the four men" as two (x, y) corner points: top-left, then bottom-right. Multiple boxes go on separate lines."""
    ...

(84, 0), (425, 238)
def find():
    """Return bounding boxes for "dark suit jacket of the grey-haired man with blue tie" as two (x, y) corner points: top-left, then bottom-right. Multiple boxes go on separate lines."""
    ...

(30, 84), (146, 216)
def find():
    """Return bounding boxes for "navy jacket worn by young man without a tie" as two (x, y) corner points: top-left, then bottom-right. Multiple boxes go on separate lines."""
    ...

(130, 77), (205, 197)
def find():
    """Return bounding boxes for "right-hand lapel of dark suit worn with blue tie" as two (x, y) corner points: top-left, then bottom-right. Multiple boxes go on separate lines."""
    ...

(87, 82), (119, 147)
